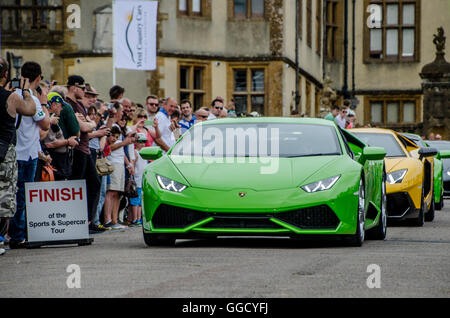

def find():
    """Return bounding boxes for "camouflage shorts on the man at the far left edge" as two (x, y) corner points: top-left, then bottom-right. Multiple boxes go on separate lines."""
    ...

(0, 145), (18, 218)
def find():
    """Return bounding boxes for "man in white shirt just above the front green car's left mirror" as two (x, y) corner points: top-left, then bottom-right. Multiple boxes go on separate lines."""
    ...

(155, 97), (177, 153)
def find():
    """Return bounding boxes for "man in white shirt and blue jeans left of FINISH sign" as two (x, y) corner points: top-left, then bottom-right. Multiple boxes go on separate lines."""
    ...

(8, 62), (50, 248)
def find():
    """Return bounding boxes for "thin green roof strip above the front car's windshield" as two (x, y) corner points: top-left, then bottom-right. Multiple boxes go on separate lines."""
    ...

(199, 117), (336, 127)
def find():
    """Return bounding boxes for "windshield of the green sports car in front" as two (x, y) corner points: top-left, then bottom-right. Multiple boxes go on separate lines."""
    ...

(170, 120), (342, 158)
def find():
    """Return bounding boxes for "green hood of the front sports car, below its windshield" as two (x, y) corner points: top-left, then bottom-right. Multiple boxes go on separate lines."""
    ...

(171, 156), (339, 191)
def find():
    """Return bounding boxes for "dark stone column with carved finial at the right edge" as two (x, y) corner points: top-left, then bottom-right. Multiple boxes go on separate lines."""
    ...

(420, 27), (450, 140)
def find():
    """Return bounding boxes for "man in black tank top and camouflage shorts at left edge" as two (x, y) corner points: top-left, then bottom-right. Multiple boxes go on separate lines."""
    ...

(0, 57), (36, 255)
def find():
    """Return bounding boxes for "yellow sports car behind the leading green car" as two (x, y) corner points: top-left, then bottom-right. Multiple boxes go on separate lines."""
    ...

(351, 128), (437, 226)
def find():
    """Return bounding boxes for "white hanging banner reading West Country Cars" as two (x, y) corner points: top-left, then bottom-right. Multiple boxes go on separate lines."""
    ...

(113, 0), (158, 71)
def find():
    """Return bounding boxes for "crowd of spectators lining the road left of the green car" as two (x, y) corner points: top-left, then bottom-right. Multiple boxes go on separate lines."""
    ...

(0, 58), (236, 253)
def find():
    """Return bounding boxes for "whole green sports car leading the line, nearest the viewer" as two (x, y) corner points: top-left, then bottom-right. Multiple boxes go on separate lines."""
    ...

(140, 118), (386, 246)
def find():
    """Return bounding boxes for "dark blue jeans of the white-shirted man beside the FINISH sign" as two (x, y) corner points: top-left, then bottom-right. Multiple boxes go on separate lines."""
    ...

(8, 158), (38, 242)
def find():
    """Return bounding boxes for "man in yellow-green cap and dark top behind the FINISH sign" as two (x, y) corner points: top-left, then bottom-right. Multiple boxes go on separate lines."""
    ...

(42, 93), (78, 181)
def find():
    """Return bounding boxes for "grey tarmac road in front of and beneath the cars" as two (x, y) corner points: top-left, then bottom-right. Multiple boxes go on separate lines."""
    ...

(0, 200), (450, 298)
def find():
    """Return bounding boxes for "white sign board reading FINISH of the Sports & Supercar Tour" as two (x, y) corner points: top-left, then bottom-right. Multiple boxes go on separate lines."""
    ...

(25, 180), (89, 242)
